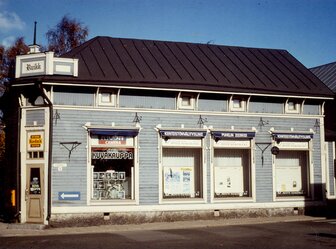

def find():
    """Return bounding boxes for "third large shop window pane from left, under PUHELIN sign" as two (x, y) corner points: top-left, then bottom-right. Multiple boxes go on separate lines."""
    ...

(213, 149), (252, 198)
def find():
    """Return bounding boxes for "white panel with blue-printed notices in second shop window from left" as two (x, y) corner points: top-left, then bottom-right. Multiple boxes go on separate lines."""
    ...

(164, 167), (195, 198)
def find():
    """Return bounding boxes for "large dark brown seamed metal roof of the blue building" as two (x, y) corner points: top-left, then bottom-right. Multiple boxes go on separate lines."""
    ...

(13, 37), (332, 97)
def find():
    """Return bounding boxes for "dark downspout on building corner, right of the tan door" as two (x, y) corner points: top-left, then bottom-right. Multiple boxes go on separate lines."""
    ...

(38, 82), (53, 221)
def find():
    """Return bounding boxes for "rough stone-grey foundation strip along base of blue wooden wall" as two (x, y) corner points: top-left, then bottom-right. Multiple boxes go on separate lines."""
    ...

(49, 208), (305, 227)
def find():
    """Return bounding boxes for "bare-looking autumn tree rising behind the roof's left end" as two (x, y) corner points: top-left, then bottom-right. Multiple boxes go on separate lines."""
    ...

(46, 16), (89, 56)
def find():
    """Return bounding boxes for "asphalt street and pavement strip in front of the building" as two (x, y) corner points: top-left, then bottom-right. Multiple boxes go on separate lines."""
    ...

(0, 216), (336, 249)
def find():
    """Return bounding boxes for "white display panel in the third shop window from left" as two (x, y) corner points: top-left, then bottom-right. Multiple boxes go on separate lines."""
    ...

(215, 166), (244, 197)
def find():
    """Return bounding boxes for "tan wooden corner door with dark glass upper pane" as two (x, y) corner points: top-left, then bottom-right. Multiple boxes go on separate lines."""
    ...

(26, 164), (44, 223)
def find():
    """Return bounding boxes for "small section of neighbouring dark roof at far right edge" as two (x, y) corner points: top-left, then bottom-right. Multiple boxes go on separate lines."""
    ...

(310, 62), (336, 93)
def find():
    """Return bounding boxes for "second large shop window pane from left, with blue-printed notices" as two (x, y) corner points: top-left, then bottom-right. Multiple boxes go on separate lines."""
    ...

(162, 148), (203, 199)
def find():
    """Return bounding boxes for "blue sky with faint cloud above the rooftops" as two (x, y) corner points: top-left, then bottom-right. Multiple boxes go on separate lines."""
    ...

(0, 0), (336, 68)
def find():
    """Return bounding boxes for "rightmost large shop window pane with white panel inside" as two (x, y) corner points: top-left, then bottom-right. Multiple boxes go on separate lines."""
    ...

(275, 150), (309, 197)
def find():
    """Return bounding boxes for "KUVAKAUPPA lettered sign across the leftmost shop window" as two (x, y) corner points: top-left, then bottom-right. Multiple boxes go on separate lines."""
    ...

(91, 148), (134, 160)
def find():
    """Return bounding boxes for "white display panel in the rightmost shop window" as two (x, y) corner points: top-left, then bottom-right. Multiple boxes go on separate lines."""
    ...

(275, 166), (303, 195)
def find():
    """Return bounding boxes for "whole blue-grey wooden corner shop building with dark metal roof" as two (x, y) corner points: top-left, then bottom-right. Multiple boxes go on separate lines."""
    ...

(11, 37), (335, 224)
